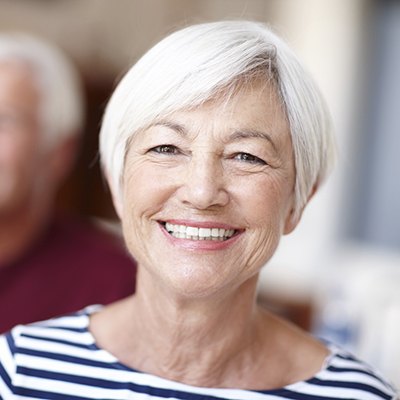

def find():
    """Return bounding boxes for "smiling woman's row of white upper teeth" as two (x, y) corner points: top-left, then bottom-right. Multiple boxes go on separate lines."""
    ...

(165, 222), (235, 240)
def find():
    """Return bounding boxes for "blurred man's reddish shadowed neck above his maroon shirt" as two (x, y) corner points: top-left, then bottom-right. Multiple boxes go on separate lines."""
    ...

(0, 203), (50, 268)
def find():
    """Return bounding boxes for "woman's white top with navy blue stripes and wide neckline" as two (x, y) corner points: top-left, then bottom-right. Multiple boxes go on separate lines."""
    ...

(0, 306), (396, 400)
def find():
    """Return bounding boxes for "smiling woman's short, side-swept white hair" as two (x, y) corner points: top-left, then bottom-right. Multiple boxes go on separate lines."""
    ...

(100, 20), (335, 215)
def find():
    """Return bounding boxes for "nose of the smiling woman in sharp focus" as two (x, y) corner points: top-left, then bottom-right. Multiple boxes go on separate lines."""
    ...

(179, 154), (229, 210)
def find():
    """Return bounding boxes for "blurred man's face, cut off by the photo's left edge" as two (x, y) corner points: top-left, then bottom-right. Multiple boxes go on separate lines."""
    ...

(0, 61), (45, 218)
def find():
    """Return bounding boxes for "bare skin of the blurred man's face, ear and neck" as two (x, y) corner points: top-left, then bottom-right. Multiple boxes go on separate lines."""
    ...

(0, 61), (73, 268)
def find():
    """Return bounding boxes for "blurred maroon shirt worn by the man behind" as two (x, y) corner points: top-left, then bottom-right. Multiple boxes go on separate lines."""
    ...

(0, 214), (136, 333)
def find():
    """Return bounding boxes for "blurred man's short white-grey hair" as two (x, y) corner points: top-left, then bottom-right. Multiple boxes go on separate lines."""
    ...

(0, 32), (85, 147)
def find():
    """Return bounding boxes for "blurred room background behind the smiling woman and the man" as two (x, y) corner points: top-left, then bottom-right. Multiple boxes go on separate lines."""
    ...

(0, 0), (400, 386)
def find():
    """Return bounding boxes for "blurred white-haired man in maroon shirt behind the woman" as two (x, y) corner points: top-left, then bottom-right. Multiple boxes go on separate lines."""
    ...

(0, 34), (136, 332)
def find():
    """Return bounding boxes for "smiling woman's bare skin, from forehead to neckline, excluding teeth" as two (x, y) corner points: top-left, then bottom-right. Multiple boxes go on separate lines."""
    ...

(90, 82), (327, 389)
